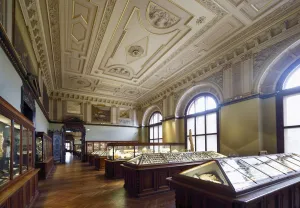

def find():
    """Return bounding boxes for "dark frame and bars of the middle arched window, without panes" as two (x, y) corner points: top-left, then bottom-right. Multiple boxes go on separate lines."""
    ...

(184, 93), (220, 152)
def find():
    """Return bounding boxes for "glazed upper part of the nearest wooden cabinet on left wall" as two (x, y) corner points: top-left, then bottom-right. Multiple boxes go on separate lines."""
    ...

(0, 97), (34, 189)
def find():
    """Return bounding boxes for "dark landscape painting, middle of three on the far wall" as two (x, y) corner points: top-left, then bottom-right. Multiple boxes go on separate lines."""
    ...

(92, 105), (111, 123)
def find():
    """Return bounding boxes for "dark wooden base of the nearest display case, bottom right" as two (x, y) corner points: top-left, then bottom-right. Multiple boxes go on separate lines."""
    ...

(168, 177), (300, 208)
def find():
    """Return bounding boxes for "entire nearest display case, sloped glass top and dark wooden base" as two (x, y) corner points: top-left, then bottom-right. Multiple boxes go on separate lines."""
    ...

(168, 154), (300, 208)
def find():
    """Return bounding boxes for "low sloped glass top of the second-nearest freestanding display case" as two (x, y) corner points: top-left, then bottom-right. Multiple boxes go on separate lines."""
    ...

(127, 151), (226, 166)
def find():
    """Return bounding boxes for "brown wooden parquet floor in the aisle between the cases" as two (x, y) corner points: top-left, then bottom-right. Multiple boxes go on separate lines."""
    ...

(34, 154), (175, 208)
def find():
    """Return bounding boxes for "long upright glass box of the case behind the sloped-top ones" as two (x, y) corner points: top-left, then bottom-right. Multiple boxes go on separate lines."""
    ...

(107, 143), (185, 160)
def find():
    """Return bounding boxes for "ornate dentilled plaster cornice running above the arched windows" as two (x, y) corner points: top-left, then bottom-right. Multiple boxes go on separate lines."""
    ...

(138, 5), (300, 106)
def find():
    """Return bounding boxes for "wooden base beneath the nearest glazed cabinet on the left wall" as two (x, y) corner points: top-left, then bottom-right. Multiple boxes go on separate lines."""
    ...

(0, 169), (39, 208)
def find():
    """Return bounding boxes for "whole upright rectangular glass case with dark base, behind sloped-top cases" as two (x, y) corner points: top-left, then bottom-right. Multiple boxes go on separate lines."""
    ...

(105, 143), (185, 179)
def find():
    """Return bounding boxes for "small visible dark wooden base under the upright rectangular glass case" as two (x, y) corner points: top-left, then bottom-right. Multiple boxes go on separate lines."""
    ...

(105, 160), (125, 179)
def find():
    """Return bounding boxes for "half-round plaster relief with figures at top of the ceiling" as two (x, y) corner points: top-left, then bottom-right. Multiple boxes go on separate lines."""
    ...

(147, 2), (180, 29)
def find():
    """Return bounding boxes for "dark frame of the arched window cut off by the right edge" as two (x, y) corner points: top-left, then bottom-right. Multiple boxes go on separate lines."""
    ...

(275, 59), (300, 153)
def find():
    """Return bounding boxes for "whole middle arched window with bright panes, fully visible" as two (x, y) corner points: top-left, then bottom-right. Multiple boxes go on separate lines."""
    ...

(185, 94), (219, 152)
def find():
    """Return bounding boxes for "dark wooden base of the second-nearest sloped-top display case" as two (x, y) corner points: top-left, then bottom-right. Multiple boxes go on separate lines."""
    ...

(122, 162), (202, 197)
